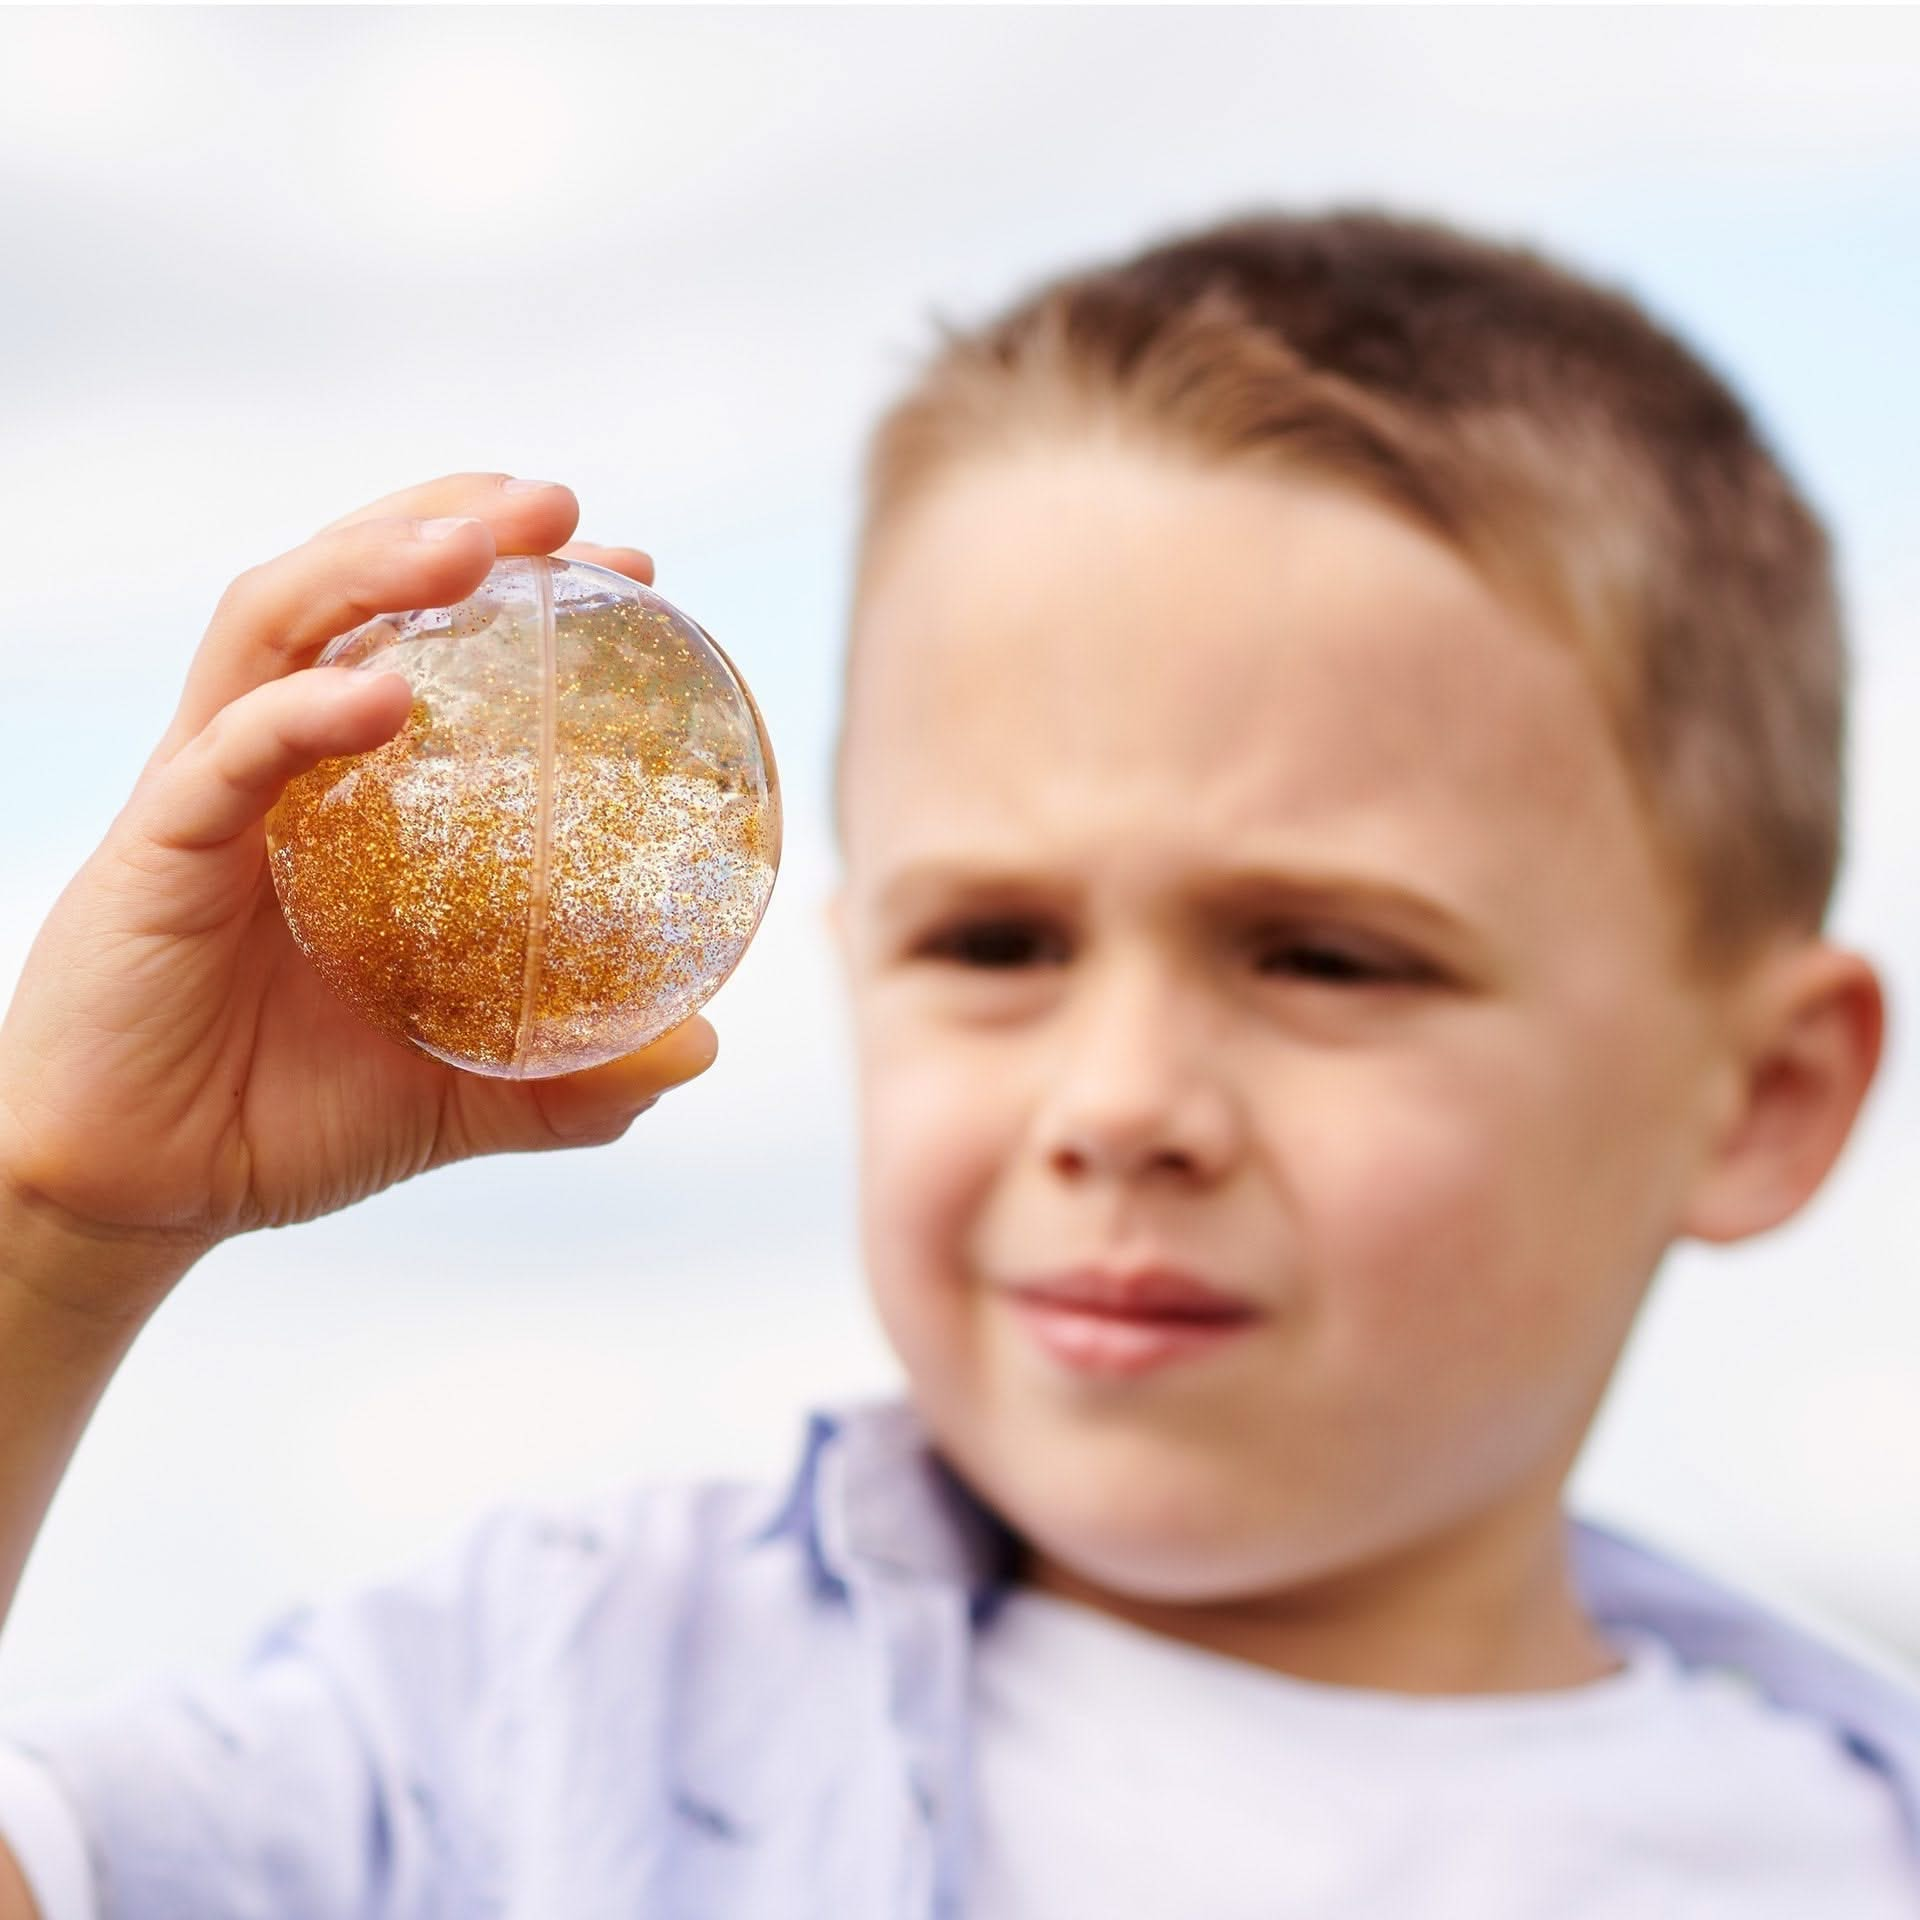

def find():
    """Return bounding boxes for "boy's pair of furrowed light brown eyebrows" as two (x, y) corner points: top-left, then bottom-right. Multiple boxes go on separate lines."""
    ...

(874, 858), (1482, 956)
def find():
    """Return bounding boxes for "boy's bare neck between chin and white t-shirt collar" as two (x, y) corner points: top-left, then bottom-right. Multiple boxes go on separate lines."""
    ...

(1023, 1498), (1620, 1693)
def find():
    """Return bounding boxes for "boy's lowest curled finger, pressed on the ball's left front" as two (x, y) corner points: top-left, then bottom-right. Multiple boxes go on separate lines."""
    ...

(132, 666), (413, 854)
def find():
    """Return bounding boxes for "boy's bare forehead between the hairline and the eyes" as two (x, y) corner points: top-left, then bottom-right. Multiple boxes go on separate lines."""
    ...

(843, 445), (1649, 960)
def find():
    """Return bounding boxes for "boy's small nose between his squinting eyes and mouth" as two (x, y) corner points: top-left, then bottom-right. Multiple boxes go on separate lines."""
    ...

(1037, 948), (1244, 1185)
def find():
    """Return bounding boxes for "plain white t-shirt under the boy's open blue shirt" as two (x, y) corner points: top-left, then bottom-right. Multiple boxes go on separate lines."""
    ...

(966, 1588), (1920, 1920)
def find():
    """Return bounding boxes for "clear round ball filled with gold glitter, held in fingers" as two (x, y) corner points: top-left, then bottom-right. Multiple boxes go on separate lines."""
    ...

(267, 555), (780, 1079)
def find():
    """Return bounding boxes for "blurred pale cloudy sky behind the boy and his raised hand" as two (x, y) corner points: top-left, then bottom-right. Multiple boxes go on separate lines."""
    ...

(0, 8), (1920, 1709)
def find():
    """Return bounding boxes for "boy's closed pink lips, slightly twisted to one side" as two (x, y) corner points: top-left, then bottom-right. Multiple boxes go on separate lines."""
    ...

(1006, 1267), (1261, 1379)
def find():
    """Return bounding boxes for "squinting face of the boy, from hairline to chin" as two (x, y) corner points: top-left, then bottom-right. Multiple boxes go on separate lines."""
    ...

(837, 444), (1713, 1599)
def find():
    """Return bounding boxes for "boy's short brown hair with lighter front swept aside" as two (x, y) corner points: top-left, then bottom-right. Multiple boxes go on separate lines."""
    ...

(849, 209), (1847, 973)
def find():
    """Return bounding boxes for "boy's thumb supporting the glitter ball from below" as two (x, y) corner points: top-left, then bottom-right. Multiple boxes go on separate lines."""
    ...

(451, 1014), (720, 1158)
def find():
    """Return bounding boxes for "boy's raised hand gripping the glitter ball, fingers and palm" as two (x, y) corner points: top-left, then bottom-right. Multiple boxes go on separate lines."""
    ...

(0, 474), (716, 1306)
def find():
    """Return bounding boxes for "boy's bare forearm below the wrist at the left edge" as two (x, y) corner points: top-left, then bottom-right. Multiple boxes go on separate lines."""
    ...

(0, 1181), (194, 1624)
